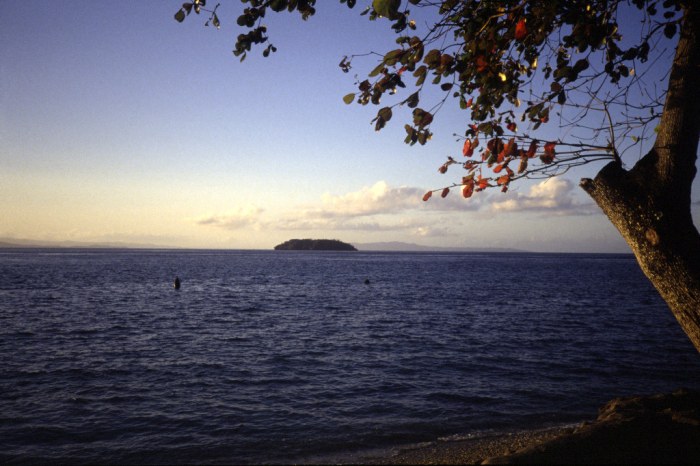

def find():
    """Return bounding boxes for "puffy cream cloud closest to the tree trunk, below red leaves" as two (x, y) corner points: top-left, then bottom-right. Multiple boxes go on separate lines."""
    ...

(490, 178), (598, 215)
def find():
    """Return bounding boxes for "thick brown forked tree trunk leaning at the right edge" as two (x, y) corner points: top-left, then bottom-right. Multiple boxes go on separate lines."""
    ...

(581, 2), (700, 351)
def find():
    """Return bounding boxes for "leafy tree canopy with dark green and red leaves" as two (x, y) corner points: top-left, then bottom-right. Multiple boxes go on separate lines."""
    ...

(175, 0), (684, 200)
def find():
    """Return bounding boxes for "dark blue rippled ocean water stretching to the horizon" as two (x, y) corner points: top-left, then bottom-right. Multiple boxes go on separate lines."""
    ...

(0, 249), (700, 463)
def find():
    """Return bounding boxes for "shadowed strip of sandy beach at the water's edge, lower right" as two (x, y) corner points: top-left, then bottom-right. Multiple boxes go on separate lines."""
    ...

(360, 389), (700, 464)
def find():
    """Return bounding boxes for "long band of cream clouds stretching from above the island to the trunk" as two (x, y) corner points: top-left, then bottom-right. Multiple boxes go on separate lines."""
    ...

(195, 178), (596, 237)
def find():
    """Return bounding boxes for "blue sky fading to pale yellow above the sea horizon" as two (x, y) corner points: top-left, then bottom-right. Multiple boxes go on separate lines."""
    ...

(0, 0), (700, 252)
